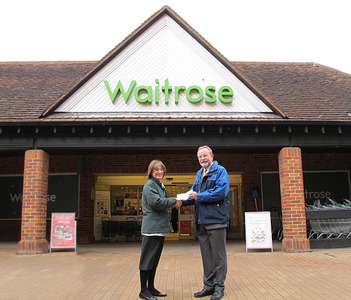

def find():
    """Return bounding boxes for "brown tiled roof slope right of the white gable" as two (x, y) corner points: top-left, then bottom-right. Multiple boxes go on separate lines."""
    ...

(232, 62), (351, 121)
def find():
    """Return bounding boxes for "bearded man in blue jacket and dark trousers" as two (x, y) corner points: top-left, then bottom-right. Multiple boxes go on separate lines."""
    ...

(182, 146), (229, 300)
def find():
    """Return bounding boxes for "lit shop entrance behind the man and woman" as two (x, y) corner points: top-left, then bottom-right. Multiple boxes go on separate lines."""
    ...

(93, 174), (244, 241)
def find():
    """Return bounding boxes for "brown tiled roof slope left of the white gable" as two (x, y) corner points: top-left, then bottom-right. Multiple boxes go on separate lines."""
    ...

(0, 62), (97, 122)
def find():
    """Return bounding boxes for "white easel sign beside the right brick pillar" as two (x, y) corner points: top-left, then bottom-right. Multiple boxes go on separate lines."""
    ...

(245, 211), (273, 253)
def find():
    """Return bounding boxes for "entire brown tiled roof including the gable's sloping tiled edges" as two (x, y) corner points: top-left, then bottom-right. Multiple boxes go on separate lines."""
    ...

(0, 6), (351, 123)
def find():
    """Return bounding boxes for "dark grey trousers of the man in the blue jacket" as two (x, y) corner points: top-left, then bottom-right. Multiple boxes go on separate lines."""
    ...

(197, 225), (227, 292)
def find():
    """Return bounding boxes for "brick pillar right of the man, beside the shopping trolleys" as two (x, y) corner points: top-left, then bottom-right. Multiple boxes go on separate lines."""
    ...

(279, 148), (310, 252)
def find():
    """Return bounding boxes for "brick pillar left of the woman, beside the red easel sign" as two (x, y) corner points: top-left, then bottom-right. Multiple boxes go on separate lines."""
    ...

(17, 150), (49, 254)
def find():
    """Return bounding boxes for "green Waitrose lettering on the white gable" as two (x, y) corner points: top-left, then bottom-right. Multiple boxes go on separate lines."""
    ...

(104, 78), (234, 105)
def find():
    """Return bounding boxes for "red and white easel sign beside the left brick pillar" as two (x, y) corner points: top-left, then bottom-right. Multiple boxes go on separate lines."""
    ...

(50, 213), (77, 252)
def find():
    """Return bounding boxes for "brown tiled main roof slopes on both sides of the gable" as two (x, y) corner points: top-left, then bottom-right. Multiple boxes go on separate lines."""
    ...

(0, 62), (351, 123)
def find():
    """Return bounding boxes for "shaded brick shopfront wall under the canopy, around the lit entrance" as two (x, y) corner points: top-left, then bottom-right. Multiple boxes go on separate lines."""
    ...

(0, 149), (351, 243)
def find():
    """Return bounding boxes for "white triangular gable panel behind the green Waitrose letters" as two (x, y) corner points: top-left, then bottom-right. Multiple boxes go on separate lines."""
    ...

(55, 15), (272, 114)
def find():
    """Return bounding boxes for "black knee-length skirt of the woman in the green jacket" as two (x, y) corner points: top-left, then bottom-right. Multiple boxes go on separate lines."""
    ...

(139, 235), (165, 271)
